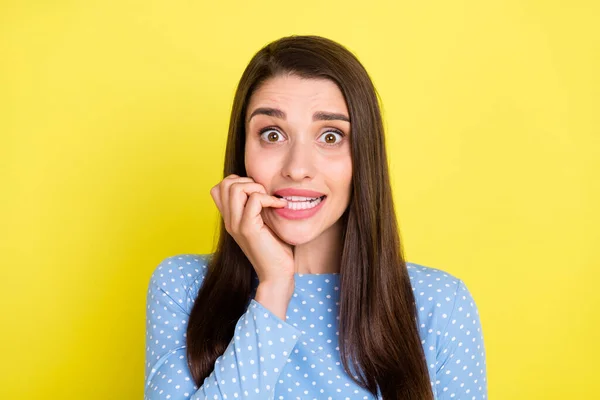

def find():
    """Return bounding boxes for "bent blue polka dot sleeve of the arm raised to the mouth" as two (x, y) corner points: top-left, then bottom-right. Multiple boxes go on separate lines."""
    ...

(144, 259), (302, 400)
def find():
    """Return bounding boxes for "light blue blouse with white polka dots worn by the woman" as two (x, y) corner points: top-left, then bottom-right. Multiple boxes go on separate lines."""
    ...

(144, 254), (487, 400)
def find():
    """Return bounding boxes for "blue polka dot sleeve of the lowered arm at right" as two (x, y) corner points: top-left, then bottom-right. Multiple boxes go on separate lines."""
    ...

(435, 280), (487, 400)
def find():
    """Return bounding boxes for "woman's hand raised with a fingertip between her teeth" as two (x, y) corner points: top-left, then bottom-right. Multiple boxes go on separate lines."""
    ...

(210, 174), (294, 295)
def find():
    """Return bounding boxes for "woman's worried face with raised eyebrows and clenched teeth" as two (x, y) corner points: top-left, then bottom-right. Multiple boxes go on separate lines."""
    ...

(245, 75), (352, 245)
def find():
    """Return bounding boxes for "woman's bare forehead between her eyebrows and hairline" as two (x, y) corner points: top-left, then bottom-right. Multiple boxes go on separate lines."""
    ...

(247, 75), (348, 113)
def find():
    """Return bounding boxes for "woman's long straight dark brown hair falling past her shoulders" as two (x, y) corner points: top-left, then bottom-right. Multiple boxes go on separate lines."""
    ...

(186, 36), (433, 400)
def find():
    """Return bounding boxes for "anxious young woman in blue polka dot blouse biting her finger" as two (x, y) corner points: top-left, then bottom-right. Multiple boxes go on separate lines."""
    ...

(145, 36), (487, 400)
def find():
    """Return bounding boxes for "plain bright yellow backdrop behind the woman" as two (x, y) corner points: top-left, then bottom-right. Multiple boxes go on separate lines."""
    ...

(0, 0), (600, 400)
